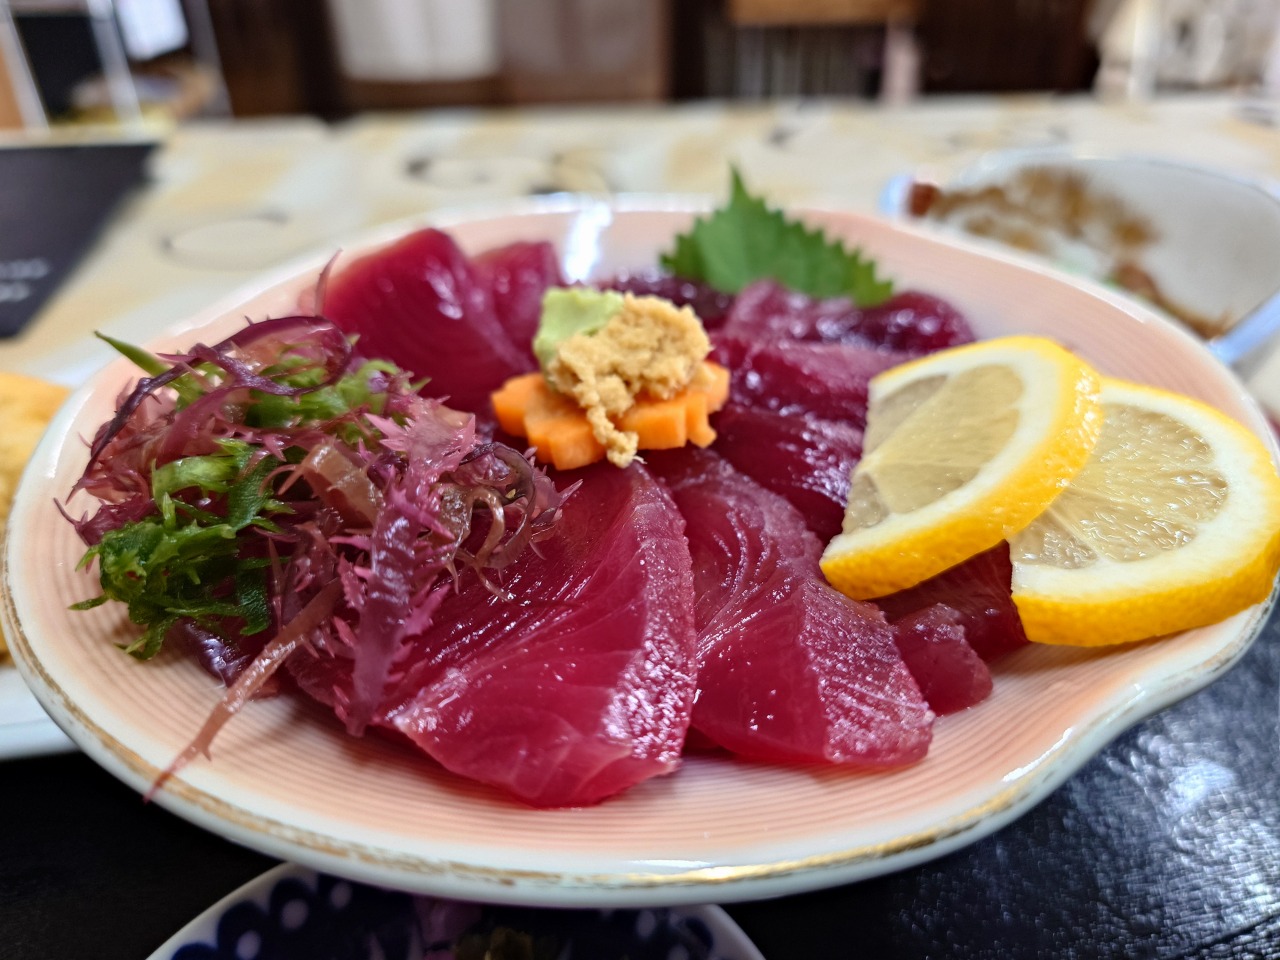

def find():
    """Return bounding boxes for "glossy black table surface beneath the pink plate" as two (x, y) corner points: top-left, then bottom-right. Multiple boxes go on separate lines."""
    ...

(0, 604), (1280, 960)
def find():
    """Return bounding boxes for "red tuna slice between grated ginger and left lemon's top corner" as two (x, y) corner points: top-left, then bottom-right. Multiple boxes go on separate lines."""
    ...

(712, 334), (910, 429)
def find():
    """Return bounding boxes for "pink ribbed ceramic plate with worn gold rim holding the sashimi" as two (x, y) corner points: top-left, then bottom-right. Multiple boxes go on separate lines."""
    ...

(4, 198), (1270, 906)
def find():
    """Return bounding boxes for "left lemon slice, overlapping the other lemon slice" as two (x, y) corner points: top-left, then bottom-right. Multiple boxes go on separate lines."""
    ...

(822, 337), (1102, 599)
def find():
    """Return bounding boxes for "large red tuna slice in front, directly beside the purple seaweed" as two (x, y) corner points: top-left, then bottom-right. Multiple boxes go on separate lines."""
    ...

(289, 465), (695, 806)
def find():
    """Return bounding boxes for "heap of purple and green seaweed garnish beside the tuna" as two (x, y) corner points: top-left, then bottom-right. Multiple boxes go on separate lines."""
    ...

(72, 316), (562, 777)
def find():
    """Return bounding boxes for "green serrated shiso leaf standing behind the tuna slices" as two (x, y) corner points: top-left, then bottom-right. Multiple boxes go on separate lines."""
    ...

(662, 168), (893, 307)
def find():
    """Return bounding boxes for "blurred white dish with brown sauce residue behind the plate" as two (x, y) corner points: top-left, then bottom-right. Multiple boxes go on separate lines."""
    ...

(881, 150), (1280, 339)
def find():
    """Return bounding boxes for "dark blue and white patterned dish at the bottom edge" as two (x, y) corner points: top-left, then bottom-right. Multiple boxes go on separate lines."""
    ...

(148, 864), (764, 960)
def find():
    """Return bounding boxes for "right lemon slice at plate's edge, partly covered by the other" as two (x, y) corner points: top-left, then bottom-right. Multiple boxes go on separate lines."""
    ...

(1010, 379), (1280, 646)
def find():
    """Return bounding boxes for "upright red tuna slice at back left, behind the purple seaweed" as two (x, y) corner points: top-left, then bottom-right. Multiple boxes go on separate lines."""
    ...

(323, 230), (530, 412)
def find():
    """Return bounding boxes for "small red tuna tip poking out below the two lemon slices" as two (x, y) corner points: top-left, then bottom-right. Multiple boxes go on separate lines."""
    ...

(893, 603), (991, 713)
